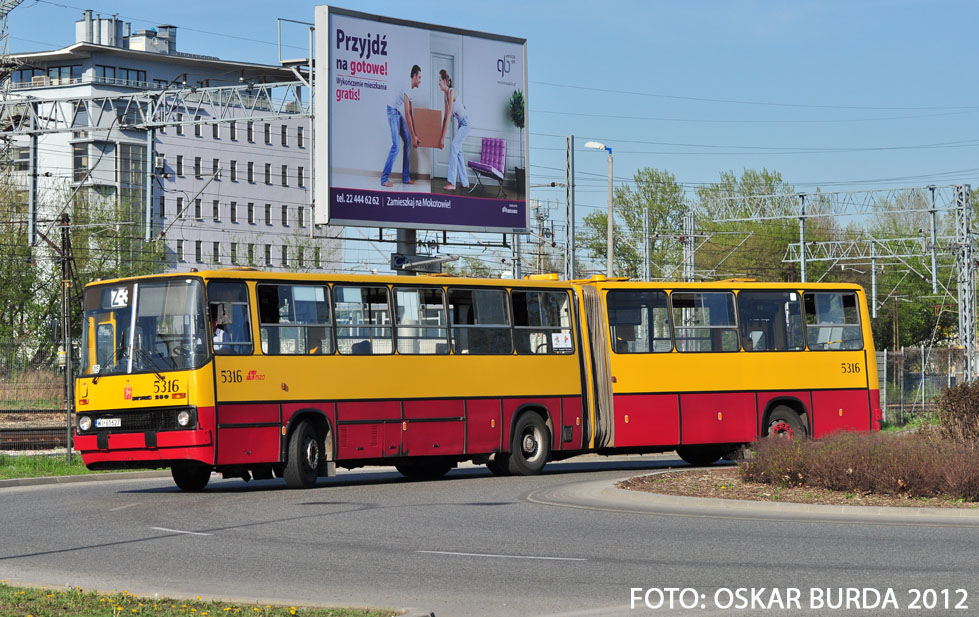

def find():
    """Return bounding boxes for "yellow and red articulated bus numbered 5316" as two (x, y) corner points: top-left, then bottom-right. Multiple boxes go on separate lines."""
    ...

(75, 268), (881, 490)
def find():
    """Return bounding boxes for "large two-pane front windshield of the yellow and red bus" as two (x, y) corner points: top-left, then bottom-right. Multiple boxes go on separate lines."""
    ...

(81, 279), (210, 377)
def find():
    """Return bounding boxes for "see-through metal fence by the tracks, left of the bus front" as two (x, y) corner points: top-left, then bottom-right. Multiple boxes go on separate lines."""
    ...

(0, 344), (71, 451)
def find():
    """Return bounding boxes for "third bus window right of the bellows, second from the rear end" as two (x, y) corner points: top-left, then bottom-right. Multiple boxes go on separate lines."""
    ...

(738, 291), (806, 351)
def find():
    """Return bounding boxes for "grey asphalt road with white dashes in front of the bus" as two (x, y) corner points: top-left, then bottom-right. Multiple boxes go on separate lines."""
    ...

(0, 456), (979, 617)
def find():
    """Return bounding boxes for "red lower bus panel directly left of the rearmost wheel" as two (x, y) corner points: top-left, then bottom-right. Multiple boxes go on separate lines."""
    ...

(680, 392), (758, 444)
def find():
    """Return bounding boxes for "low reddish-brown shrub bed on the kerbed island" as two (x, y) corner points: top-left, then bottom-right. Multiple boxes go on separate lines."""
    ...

(739, 433), (979, 501)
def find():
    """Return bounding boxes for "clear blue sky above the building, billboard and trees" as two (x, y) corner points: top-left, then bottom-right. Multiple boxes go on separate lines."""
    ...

(10, 0), (979, 226)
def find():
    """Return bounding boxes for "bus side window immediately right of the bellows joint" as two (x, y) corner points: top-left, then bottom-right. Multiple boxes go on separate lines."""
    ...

(607, 291), (673, 353)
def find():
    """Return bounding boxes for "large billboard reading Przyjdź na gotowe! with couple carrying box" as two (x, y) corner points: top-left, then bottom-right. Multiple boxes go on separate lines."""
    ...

(314, 6), (529, 233)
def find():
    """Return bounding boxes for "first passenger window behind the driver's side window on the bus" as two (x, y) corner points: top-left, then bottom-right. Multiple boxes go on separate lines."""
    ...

(256, 285), (333, 356)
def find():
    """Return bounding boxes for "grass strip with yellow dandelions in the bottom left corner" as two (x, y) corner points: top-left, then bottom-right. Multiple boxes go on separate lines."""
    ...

(0, 581), (399, 617)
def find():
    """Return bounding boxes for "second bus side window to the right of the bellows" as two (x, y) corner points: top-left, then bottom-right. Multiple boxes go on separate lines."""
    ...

(670, 291), (741, 352)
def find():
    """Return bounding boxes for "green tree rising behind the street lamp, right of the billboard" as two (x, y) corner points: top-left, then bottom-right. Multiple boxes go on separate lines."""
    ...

(576, 167), (687, 279)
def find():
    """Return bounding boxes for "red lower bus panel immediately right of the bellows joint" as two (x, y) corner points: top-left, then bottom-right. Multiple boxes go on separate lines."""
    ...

(615, 394), (680, 448)
